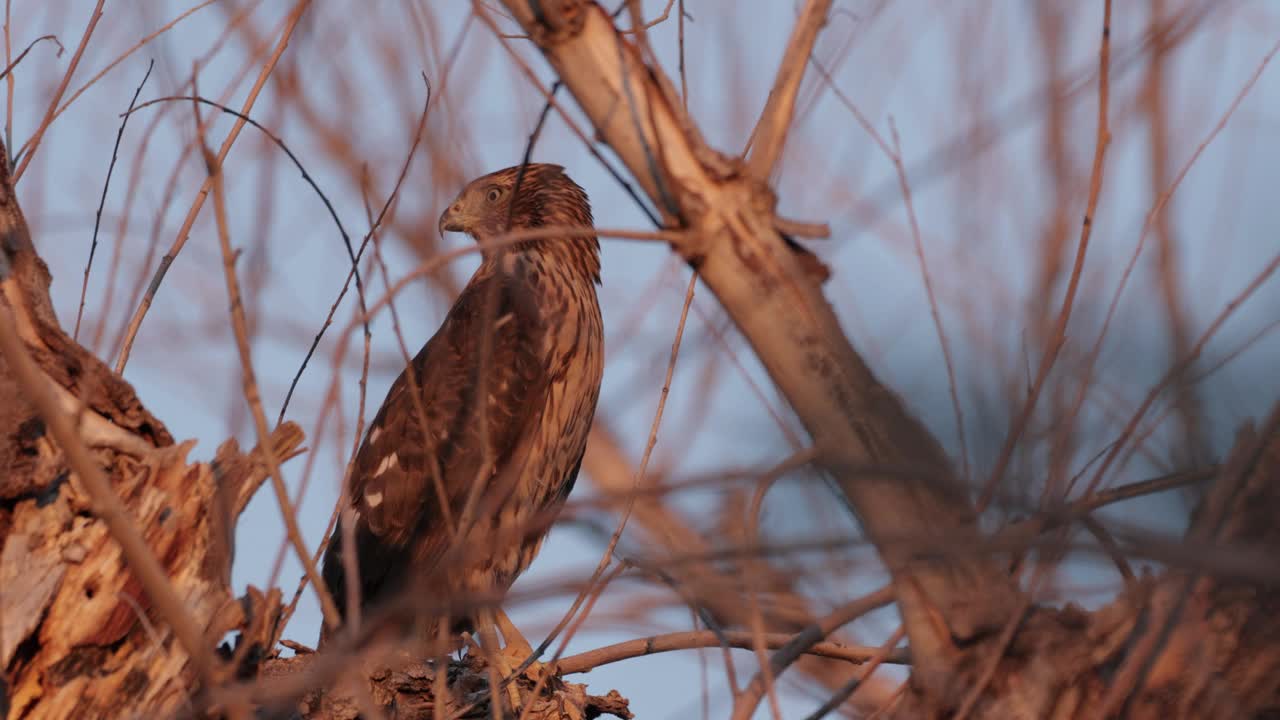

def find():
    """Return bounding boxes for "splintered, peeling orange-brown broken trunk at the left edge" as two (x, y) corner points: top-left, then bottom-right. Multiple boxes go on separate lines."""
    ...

(0, 131), (302, 719)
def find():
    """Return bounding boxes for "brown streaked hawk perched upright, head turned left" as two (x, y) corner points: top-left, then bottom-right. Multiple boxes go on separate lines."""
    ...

(321, 164), (604, 647)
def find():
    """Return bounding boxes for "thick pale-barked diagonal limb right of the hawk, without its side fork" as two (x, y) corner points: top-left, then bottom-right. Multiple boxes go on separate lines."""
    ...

(504, 0), (1018, 689)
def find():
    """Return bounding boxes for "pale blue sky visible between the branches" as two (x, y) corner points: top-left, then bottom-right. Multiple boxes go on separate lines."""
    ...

(12, 0), (1280, 717)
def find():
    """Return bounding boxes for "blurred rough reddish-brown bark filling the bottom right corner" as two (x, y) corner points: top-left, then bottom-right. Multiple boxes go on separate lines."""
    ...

(893, 417), (1280, 720)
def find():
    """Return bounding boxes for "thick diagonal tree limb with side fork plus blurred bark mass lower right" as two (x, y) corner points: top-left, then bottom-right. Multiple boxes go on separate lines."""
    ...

(494, 0), (1280, 719)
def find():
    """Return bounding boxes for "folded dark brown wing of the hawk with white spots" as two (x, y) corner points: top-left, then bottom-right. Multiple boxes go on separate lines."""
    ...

(324, 263), (549, 617)
